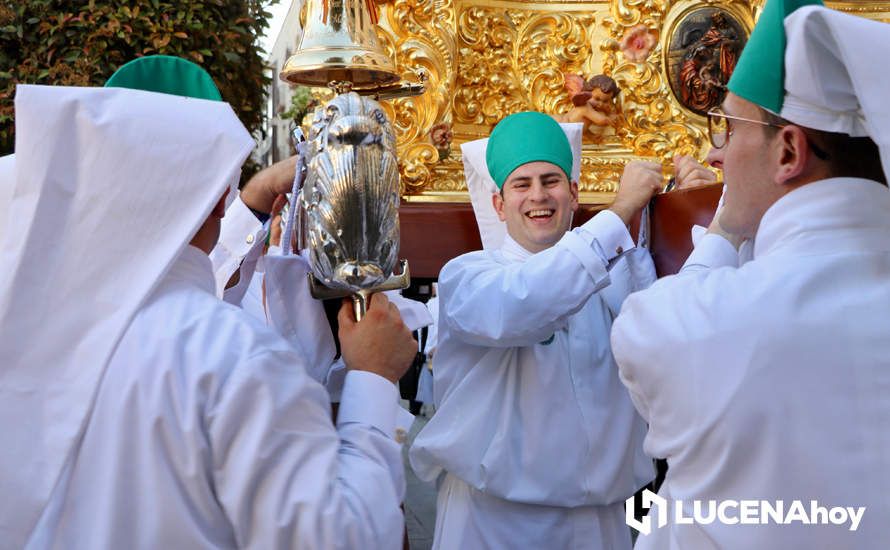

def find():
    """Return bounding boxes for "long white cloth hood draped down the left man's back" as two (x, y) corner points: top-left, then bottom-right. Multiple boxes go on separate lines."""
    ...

(0, 86), (253, 548)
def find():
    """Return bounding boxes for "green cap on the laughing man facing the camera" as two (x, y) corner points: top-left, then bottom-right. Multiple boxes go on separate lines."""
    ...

(485, 111), (572, 189)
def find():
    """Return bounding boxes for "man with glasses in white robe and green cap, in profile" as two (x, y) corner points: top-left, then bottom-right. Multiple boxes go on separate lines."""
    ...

(612, 0), (890, 549)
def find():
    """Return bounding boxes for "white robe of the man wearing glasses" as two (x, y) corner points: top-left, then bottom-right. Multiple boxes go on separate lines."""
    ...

(612, 178), (890, 550)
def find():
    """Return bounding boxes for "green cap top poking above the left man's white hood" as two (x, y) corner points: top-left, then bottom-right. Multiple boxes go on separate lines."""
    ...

(105, 55), (222, 101)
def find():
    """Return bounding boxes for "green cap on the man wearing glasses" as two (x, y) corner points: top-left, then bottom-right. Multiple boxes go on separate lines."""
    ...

(727, 0), (822, 114)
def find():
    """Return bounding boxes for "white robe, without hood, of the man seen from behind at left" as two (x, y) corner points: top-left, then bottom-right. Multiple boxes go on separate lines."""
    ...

(28, 247), (404, 549)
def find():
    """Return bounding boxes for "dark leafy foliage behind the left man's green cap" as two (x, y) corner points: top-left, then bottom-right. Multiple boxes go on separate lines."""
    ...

(0, 0), (278, 175)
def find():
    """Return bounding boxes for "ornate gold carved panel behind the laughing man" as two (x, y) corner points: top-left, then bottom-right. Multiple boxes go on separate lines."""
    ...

(368, 0), (890, 204)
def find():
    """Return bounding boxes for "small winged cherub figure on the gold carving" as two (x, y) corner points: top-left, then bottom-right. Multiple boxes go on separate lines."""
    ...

(553, 74), (621, 133)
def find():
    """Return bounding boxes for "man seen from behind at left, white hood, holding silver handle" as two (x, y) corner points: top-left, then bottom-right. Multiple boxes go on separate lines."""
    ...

(0, 58), (416, 548)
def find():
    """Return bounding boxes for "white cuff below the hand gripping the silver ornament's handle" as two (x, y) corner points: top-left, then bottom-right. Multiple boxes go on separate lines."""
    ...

(337, 370), (399, 437)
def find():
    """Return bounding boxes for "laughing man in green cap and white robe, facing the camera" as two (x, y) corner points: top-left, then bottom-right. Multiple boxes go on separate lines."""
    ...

(411, 112), (661, 549)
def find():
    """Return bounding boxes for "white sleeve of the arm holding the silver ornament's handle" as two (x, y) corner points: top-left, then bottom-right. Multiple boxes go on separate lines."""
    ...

(207, 358), (405, 549)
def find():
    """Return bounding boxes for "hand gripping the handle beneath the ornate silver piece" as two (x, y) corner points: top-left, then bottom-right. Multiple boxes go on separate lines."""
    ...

(337, 292), (417, 384)
